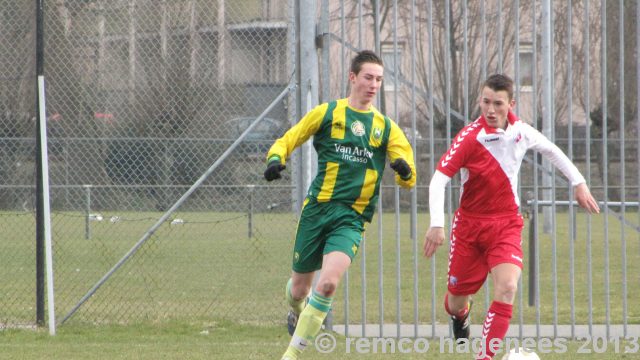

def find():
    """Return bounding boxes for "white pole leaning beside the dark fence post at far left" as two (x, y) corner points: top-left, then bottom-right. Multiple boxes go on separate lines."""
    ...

(38, 75), (56, 335)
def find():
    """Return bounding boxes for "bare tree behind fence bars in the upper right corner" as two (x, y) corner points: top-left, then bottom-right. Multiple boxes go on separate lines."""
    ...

(552, 1), (637, 200)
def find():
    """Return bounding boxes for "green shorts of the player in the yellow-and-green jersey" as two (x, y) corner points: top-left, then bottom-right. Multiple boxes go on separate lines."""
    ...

(292, 198), (364, 273)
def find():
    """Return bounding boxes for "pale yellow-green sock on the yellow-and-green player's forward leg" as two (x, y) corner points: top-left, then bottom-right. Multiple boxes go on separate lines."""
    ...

(282, 292), (332, 359)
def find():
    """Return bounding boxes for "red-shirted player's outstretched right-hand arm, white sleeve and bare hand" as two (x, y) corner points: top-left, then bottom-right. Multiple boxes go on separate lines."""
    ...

(530, 124), (600, 213)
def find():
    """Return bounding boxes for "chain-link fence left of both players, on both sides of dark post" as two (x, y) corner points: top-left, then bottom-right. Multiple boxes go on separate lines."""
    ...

(0, 0), (295, 326)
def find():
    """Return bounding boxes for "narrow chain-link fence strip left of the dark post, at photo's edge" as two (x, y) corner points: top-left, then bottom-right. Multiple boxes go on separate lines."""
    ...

(0, 1), (36, 325)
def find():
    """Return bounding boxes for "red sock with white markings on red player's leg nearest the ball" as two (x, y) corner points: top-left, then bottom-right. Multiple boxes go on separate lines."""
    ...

(477, 301), (513, 359)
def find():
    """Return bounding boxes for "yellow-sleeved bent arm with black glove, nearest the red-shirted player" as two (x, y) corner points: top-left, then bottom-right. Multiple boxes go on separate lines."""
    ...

(387, 121), (417, 189)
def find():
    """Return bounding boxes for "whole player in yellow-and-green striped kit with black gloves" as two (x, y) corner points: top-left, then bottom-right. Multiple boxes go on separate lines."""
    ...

(264, 50), (416, 359)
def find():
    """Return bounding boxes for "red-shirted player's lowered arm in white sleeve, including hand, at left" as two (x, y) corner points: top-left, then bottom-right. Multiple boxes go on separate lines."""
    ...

(424, 170), (451, 257)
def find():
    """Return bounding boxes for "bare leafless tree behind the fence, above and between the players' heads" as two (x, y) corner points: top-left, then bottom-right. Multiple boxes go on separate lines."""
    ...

(332, 0), (531, 134)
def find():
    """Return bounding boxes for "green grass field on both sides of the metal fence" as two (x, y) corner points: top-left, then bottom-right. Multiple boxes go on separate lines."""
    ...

(0, 212), (640, 359)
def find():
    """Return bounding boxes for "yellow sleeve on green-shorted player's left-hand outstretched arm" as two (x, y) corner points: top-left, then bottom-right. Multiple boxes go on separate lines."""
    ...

(267, 103), (329, 165)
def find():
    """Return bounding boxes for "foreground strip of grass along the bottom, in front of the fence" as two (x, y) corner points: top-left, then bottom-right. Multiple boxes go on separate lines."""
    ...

(0, 321), (639, 360)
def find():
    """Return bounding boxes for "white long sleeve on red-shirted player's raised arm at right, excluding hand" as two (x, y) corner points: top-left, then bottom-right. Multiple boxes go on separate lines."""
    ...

(525, 124), (586, 186)
